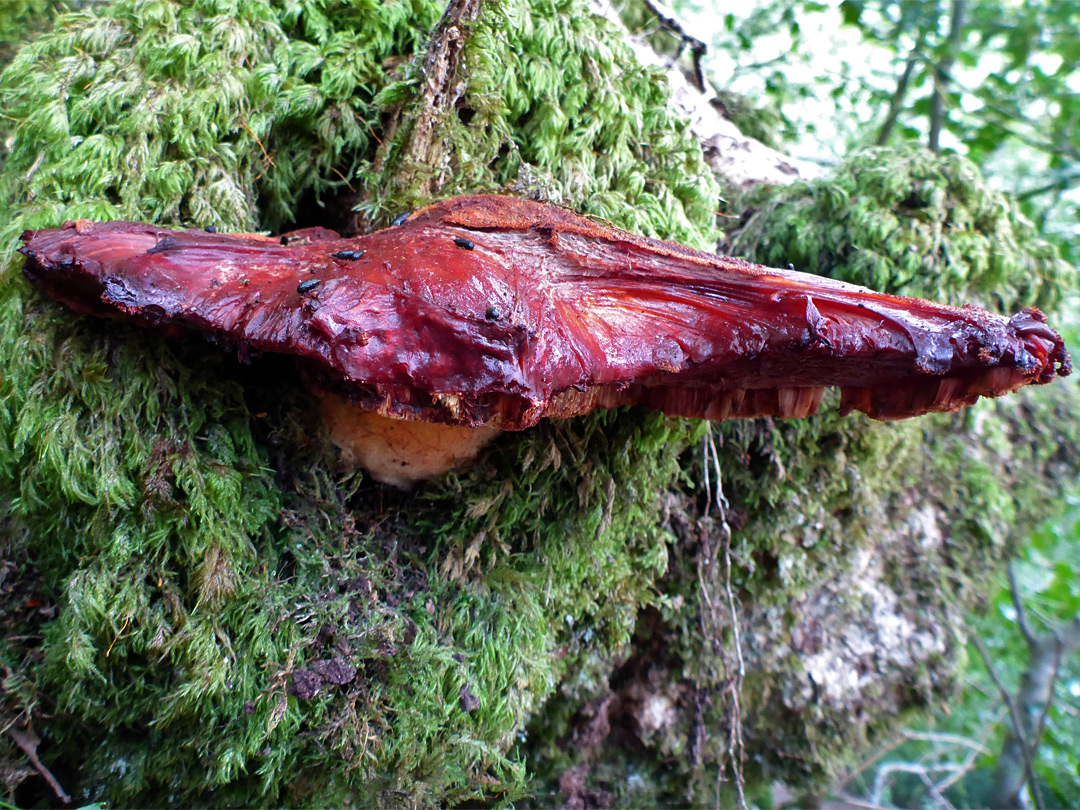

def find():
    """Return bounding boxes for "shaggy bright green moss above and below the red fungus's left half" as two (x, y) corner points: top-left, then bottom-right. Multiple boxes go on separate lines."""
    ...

(0, 0), (718, 806)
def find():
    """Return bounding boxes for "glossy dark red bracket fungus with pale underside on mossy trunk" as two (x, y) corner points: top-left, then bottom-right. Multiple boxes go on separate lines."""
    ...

(22, 195), (1070, 485)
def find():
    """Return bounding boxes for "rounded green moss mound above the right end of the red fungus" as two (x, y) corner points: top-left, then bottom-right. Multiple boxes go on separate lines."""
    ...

(728, 149), (1076, 312)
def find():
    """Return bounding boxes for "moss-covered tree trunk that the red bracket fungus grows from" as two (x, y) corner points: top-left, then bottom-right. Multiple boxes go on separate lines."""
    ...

(0, 0), (1076, 806)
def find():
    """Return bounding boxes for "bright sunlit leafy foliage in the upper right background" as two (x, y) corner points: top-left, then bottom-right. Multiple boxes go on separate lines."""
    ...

(677, 0), (1080, 264)
